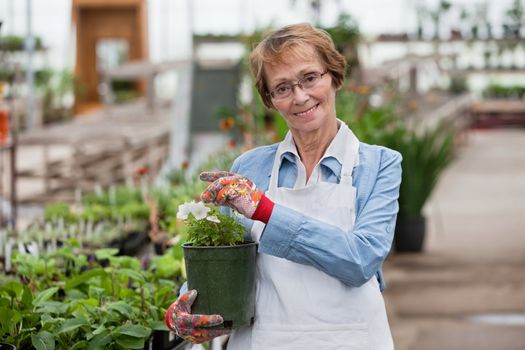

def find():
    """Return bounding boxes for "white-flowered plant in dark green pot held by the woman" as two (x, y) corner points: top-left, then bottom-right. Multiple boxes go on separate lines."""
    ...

(177, 201), (257, 328)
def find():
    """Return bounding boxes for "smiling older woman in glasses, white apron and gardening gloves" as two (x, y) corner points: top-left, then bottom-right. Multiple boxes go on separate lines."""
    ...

(167, 24), (401, 350)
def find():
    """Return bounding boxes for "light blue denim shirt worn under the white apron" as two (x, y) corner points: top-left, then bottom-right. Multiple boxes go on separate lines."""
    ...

(231, 142), (401, 290)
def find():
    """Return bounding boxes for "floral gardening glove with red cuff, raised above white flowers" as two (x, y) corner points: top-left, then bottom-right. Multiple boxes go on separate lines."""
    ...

(200, 171), (274, 224)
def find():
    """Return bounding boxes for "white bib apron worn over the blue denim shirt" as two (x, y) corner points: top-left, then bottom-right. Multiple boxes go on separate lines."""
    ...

(228, 123), (394, 350)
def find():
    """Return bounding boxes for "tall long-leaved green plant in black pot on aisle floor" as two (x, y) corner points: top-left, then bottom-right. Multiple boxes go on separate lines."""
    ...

(385, 123), (455, 252)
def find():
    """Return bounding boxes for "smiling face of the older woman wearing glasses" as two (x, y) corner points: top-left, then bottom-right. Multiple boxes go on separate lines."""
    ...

(264, 47), (336, 137)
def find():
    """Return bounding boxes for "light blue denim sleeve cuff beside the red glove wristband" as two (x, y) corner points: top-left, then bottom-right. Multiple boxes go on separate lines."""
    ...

(259, 203), (303, 258)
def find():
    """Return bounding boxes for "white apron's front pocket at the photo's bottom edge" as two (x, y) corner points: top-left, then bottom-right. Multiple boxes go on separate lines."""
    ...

(252, 323), (370, 350)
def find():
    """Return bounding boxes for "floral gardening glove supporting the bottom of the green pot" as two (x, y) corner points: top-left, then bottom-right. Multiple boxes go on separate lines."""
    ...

(166, 290), (231, 344)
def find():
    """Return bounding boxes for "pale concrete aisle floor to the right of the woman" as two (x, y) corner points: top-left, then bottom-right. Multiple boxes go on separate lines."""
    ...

(384, 129), (525, 350)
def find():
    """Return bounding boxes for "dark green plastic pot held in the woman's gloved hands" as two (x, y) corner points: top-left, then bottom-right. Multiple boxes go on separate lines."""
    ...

(183, 242), (257, 329)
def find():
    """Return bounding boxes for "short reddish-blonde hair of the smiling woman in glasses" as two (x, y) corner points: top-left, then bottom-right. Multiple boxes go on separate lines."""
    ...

(250, 23), (346, 108)
